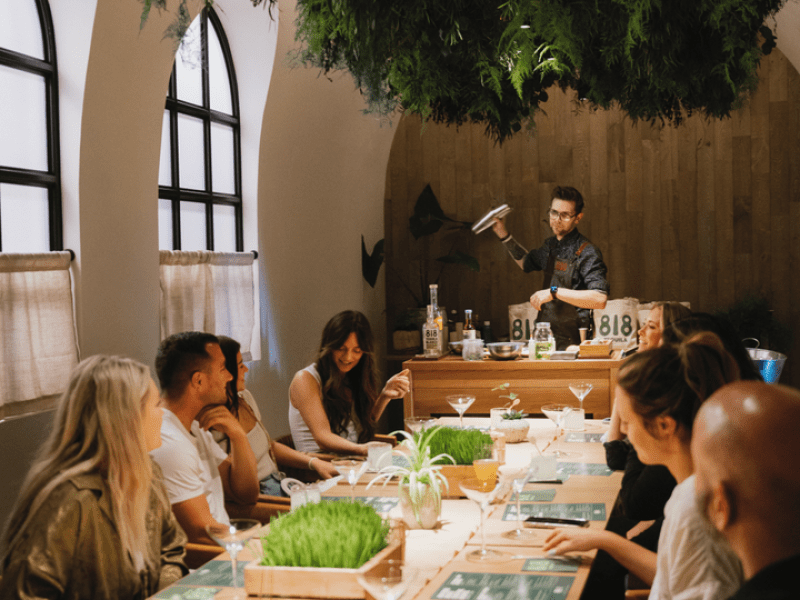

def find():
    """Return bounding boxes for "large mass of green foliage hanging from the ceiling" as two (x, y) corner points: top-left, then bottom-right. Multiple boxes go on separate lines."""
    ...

(297, 0), (783, 142)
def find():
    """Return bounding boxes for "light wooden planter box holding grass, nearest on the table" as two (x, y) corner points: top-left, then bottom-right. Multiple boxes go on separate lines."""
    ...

(244, 523), (405, 599)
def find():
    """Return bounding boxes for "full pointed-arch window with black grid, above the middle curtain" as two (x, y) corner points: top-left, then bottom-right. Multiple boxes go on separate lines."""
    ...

(158, 9), (243, 252)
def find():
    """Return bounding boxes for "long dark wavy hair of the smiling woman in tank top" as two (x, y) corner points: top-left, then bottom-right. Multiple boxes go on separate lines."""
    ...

(316, 310), (378, 444)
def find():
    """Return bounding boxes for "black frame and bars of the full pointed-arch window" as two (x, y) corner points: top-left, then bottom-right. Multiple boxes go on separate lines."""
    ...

(158, 8), (244, 252)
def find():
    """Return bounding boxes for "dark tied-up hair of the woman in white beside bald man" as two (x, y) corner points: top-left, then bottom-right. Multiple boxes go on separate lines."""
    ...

(617, 331), (739, 440)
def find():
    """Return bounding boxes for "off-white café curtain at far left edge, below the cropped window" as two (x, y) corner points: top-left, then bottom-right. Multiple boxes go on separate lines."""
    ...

(0, 252), (79, 418)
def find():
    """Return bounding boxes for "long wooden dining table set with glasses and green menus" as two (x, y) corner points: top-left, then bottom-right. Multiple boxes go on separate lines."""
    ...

(154, 417), (622, 600)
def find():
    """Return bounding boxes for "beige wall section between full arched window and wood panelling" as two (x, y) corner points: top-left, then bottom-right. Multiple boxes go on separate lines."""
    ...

(248, 2), (394, 435)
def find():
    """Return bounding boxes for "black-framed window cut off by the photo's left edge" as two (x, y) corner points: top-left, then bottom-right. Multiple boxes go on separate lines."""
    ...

(0, 0), (63, 252)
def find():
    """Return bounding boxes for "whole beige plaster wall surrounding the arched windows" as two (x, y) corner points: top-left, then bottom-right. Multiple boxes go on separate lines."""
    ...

(0, 0), (393, 520)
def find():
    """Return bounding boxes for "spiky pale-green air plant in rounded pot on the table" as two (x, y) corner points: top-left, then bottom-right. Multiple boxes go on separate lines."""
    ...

(367, 427), (455, 529)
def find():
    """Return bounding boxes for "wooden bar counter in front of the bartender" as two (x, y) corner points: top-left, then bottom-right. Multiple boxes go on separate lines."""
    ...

(403, 351), (622, 419)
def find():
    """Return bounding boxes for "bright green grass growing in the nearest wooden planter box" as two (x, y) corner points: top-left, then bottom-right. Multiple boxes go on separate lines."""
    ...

(261, 502), (389, 569)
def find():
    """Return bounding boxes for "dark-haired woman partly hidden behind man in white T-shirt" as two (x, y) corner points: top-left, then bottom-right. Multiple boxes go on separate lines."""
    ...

(205, 335), (338, 496)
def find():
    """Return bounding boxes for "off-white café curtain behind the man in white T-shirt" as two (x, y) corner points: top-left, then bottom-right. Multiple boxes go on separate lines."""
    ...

(160, 250), (261, 361)
